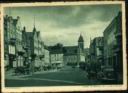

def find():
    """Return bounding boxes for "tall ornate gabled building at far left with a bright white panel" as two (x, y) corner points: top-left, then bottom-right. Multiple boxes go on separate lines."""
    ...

(4, 15), (24, 68)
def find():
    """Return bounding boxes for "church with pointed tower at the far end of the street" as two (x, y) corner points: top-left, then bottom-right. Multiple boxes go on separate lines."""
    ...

(63, 35), (85, 66)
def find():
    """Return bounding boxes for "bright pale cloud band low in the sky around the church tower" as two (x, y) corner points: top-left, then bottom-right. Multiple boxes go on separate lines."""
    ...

(41, 21), (109, 47)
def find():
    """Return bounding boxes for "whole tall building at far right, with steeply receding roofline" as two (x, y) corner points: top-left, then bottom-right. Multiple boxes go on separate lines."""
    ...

(104, 12), (123, 82)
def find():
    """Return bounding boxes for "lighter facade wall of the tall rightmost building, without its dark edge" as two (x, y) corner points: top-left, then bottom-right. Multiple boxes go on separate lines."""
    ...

(104, 12), (121, 67)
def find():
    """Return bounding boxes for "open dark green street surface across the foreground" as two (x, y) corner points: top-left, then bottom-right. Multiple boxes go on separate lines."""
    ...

(5, 67), (100, 87)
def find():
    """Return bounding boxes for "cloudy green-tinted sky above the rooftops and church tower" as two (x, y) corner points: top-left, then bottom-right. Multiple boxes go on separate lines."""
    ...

(5, 5), (121, 47)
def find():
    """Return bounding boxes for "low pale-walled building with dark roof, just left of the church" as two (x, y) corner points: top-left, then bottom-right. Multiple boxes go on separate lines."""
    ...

(49, 43), (63, 68)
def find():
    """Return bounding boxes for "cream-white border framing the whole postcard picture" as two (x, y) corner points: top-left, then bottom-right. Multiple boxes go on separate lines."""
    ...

(1, 1), (127, 92)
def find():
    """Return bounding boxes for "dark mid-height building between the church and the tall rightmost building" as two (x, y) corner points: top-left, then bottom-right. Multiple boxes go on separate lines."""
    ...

(90, 37), (103, 73)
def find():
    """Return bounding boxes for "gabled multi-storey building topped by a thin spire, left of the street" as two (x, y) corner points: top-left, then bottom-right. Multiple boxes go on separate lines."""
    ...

(26, 27), (44, 72)
